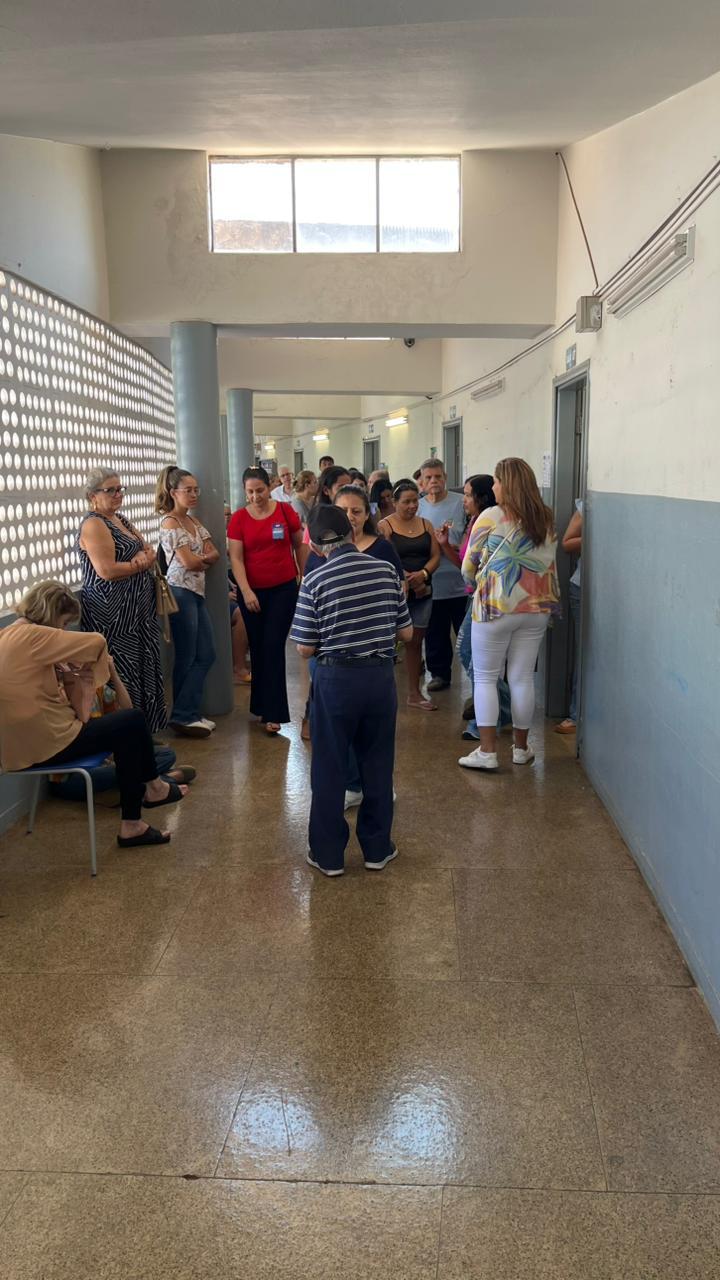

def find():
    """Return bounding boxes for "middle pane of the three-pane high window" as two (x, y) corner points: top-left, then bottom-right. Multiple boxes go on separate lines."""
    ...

(295, 159), (377, 253)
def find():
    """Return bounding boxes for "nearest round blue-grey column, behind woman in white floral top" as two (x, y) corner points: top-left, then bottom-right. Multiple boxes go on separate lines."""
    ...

(170, 320), (234, 716)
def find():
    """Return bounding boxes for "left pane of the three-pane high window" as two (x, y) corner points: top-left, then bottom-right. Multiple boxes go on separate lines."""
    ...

(210, 160), (292, 253)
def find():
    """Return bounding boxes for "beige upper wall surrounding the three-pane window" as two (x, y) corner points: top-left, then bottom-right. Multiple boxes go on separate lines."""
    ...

(101, 150), (557, 334)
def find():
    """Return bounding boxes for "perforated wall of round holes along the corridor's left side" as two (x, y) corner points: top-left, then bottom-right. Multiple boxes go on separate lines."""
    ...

(0, 270), (176, 613)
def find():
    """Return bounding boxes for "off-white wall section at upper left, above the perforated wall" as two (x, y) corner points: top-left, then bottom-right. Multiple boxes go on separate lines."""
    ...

(0, 134), (109, 320)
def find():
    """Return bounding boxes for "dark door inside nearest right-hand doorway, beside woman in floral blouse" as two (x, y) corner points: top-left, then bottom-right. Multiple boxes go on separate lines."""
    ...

(546, 366), (588, 741)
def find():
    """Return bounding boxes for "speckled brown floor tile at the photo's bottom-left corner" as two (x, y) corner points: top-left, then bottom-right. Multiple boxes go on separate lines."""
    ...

(0, 1175), (441, 1280)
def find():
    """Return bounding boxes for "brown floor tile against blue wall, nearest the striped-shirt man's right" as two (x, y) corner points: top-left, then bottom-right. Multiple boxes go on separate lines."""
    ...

(452, 868), (692, 986)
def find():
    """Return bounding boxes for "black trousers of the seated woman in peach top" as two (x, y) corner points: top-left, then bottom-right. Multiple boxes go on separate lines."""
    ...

(36, 709), (158, 822)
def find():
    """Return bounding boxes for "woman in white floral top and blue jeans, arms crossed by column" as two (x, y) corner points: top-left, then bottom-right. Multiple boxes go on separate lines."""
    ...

(155, 466), (220, 737)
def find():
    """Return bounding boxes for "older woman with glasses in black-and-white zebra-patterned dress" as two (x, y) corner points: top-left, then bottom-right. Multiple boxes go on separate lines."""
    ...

(77, 467), (168, 733)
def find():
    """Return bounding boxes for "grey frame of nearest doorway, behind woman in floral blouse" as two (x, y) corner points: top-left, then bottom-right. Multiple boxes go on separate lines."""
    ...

(544, 360), (591, 755)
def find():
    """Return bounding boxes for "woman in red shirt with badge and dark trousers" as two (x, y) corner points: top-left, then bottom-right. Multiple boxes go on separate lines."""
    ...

(228, 467), (302, 733)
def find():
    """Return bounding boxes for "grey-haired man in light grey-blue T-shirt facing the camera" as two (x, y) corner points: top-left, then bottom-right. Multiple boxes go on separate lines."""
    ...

(418, 458), (468, 692)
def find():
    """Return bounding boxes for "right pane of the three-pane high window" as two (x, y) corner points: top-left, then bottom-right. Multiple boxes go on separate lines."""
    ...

(379, 156), (460, 253)
